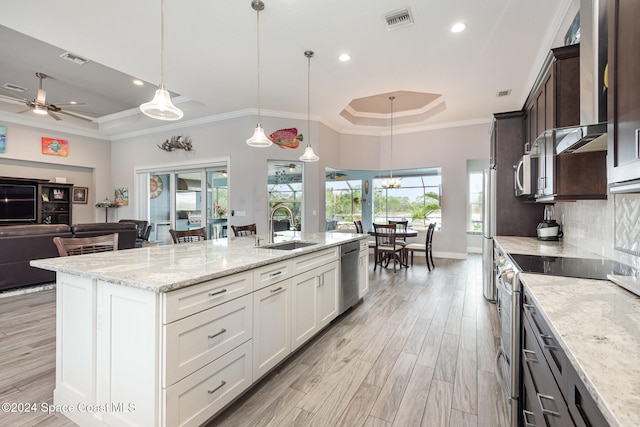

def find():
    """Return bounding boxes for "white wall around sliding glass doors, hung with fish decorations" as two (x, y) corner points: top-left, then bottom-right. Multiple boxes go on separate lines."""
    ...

(111, 117), (324, 233)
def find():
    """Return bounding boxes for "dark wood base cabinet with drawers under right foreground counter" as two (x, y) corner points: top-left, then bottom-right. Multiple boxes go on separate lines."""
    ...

(521, 290), (608, 427)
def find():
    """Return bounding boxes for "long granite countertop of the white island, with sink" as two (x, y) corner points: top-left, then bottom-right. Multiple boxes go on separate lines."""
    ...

(31, 232), (368, 292)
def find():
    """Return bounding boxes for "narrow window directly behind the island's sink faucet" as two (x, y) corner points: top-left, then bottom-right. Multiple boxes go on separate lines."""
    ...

(267, 161), (304, 231)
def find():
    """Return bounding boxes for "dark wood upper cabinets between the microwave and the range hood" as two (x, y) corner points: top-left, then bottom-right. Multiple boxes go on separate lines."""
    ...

(523, 44), (607, 202)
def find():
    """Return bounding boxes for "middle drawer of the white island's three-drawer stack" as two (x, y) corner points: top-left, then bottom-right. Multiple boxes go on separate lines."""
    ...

(162, 295), (253, 388)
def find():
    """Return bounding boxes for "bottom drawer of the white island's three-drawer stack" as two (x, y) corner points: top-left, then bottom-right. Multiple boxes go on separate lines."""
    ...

(163, 341), (253, 426)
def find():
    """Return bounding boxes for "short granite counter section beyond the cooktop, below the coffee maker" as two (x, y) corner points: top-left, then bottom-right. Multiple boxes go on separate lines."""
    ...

(495, 236), (603, 259)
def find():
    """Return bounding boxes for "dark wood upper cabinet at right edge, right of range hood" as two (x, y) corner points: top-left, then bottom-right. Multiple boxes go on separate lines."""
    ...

(608, 0), (640, 185)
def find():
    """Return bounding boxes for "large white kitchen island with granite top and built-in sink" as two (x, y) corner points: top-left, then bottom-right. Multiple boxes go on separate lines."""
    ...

(32, 232), (368, 426)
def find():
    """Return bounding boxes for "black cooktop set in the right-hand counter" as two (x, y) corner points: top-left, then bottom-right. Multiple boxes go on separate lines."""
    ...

(509, 254), (640, 280)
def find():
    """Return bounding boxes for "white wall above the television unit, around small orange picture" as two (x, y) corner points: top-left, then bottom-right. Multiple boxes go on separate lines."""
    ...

(0, 122), (113, 223)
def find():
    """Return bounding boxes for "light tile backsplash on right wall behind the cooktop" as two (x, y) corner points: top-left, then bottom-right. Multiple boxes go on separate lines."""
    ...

(555, 194), (640, 268)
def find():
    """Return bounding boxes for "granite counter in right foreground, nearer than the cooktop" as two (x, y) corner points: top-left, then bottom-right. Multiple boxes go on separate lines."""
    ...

(521, 274), (640, 427)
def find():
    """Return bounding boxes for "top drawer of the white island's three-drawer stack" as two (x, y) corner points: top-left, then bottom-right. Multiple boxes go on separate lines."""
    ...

(163, 271), (253, 324)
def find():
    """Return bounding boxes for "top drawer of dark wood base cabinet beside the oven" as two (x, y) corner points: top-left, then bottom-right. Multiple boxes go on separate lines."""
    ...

(522, 292), (570, 394)
